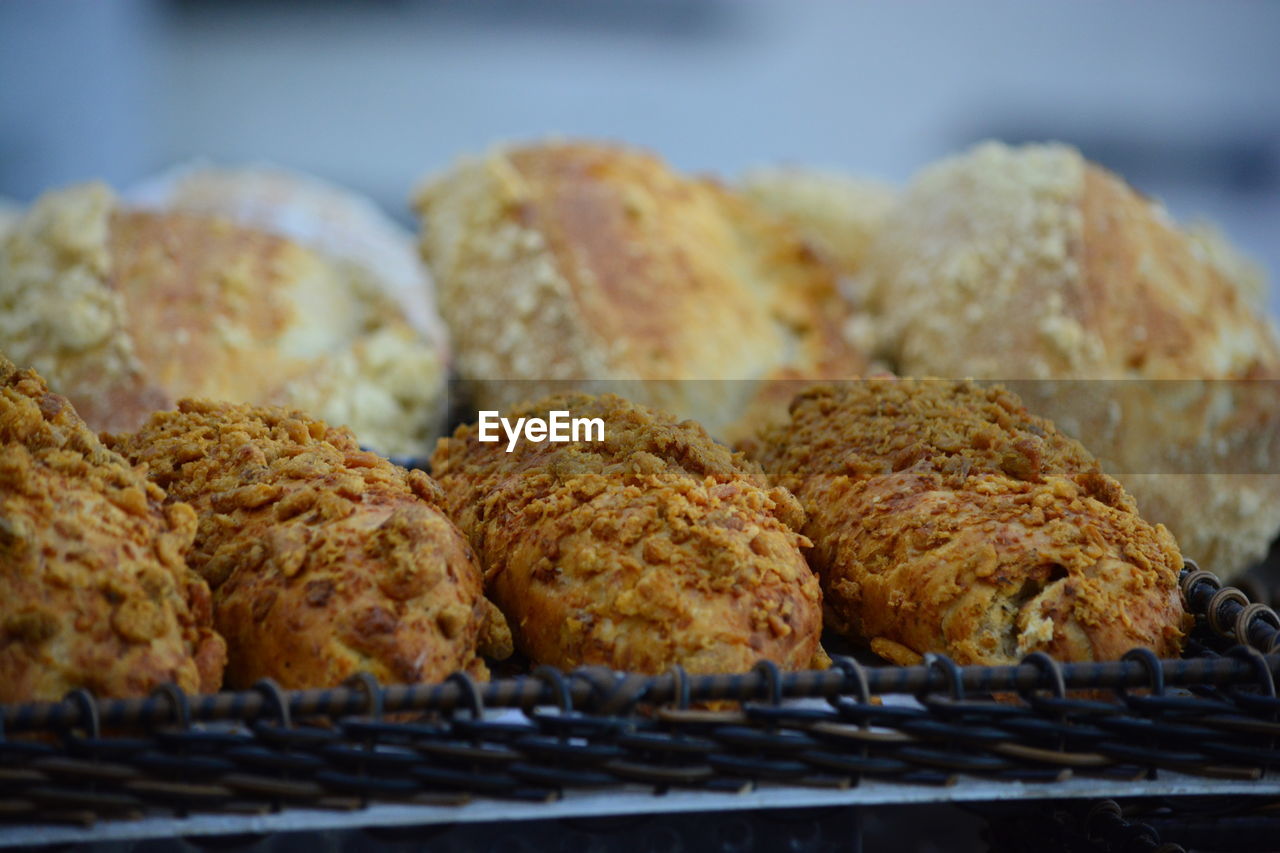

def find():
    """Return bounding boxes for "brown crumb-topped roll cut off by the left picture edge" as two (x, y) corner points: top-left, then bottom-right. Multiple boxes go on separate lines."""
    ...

(0, 356), (225, 702)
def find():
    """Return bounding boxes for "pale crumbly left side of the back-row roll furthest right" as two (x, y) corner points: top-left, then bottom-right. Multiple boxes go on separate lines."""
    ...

(865, 142), (1105, 379)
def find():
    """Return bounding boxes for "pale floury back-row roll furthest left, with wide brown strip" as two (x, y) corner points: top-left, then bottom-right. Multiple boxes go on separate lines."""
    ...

(0, 184), (445, 453)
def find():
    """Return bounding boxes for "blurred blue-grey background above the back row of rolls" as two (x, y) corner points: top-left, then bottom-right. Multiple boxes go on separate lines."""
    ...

(0, 0), (1280, 309)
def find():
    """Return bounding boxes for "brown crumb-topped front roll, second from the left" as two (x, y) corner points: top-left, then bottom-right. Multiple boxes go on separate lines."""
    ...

(108, 400), (509, 688)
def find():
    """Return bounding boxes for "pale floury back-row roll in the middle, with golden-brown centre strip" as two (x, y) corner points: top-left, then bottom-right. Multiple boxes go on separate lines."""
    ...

(416, 142), (865, 434)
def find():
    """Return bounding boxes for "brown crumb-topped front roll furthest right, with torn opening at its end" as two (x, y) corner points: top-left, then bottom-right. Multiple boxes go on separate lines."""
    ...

(750, 378), (1187, 663)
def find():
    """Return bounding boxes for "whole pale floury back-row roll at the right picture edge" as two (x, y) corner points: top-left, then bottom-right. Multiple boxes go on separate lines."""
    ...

(863, 143), (1280, 575)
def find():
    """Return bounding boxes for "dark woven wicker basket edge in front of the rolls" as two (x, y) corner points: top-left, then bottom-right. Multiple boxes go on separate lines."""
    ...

(0, 564), (1280, 849)
